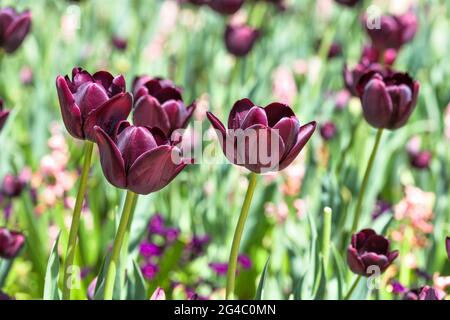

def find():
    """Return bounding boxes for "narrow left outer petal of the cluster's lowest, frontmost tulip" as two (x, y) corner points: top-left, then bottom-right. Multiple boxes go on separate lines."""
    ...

(94, 126), (127, 188)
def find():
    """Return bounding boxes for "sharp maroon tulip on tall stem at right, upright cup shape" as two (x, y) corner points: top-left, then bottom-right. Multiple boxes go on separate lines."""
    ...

(357, 71), (420, 129)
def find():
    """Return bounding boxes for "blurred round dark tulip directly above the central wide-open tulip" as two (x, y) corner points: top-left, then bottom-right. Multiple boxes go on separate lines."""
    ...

(225, 25), (260, 57)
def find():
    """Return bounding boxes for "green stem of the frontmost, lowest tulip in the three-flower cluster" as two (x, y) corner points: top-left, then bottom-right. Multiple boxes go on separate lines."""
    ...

(104, 191), (137, 300)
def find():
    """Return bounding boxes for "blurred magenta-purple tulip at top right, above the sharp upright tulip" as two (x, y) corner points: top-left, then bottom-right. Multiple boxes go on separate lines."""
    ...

(364, 12), (417, 51)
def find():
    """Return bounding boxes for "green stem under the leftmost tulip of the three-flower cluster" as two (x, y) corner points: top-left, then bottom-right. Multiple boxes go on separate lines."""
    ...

(62, 141), (94, 300)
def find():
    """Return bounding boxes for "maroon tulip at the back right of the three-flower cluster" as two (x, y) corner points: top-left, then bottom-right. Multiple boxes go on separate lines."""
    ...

(129, 76), (196, 138)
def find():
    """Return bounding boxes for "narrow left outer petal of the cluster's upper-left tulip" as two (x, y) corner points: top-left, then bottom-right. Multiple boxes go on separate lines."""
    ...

(56, 76), (84, 140)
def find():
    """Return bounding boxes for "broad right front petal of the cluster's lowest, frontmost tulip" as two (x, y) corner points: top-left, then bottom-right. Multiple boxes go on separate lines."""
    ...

(127, 145), (187, 194)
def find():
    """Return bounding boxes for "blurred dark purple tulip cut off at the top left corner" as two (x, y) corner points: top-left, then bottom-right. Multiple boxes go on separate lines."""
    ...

(0, 8), (31, 53)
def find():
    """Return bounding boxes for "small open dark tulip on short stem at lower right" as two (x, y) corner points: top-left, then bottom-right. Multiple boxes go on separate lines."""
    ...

(347, 229), (398, 277)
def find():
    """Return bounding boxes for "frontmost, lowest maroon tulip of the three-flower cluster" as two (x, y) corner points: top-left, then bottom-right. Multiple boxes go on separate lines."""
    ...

(94, 121), (187, 194)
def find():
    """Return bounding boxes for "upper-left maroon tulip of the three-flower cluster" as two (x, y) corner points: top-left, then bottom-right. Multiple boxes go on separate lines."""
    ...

(56, 68), (132, 141)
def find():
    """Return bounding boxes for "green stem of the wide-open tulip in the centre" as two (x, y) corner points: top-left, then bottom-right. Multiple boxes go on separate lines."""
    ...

(225, 172), (257, 299)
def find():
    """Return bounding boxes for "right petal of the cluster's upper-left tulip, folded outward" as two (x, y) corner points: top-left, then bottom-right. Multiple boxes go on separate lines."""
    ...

(83, 93), (133, 141)
